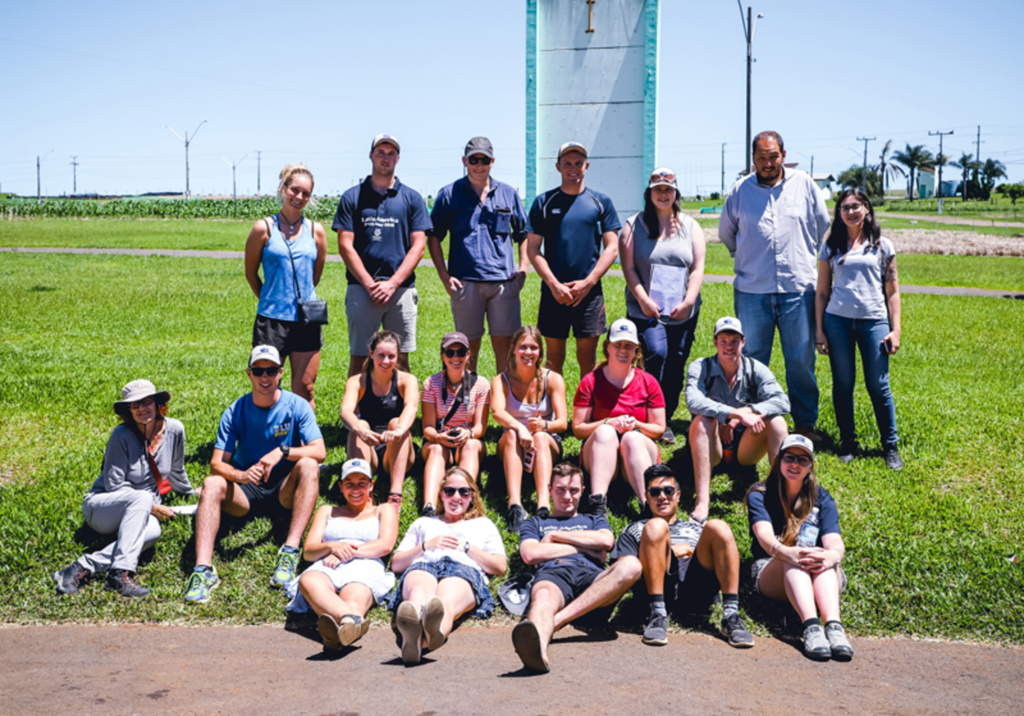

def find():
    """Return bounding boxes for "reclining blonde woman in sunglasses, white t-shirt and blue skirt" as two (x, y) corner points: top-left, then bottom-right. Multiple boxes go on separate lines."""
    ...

(387, 467), (508, 664)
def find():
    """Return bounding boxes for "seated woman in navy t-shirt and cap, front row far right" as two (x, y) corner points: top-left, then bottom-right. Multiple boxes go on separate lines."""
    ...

(746, 435), (853, 661)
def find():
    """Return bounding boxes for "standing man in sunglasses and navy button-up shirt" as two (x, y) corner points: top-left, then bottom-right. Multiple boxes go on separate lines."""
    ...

(427, 136), (529, 373)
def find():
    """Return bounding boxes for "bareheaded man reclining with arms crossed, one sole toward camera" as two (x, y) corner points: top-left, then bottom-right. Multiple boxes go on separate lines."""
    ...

(512, 462), (640, 672)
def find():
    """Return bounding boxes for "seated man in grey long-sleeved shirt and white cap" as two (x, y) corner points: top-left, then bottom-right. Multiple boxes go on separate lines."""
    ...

(686, 315), (790, 522)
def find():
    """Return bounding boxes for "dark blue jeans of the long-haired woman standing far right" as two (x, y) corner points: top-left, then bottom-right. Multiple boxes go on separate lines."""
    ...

(823, 313), (898, 448)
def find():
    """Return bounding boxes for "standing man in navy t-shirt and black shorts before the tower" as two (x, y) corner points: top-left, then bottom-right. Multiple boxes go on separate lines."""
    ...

(526, 141), (622, 378)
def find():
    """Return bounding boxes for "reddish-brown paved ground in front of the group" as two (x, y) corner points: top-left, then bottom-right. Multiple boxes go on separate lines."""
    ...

(0, 626), (1024, 716)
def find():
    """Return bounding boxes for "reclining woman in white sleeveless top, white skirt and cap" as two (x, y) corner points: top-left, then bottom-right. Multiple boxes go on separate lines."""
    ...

(287, 458), (398, 649)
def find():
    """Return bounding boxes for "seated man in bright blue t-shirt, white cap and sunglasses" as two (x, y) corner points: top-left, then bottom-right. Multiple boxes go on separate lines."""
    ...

(185, 345), (326, 602)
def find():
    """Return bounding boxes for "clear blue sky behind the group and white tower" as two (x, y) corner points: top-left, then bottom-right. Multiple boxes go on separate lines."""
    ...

(0, 0), (1024, 195)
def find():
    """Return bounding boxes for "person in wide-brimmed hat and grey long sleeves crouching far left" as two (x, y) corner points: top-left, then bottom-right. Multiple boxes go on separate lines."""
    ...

(53, 380), (196, 597)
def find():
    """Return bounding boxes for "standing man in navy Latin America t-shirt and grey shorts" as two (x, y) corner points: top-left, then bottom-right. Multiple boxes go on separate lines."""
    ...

(332, 134), (430, 376)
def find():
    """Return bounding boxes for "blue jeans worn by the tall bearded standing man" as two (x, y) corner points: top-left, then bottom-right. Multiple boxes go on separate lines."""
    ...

(733, 291), (818, 427)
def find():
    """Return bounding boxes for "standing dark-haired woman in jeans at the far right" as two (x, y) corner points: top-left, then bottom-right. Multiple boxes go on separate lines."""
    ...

(815, 188), (903, 470)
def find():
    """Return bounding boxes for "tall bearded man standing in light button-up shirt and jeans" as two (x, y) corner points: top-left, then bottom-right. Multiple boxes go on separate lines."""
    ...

(718, 131), (830, 440)
